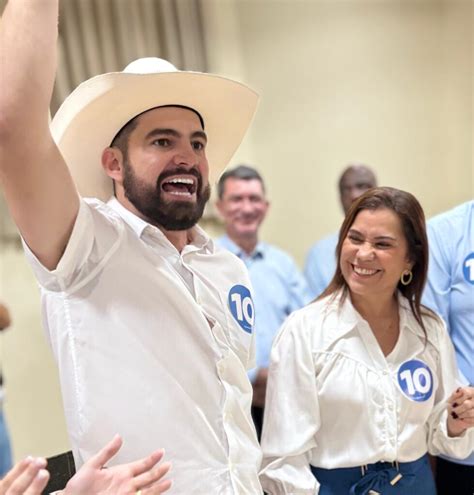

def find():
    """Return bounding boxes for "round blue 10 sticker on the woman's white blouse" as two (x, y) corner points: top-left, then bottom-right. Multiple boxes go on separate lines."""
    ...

(398, 359), (433, 402)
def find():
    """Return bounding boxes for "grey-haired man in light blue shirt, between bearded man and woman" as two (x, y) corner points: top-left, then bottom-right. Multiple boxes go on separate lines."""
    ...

(216, 165), (311, 438)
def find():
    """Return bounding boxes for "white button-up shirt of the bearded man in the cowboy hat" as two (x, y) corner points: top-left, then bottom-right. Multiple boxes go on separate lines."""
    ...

(26, 199), (261, 495)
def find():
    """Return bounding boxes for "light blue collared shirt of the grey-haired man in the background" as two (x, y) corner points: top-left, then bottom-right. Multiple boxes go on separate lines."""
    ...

(216, 236), (312, 382)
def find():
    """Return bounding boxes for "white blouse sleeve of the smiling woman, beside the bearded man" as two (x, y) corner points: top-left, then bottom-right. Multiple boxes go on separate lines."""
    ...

(260, 314), (320, 495)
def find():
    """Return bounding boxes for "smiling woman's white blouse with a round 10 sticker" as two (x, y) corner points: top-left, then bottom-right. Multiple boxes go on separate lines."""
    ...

(261, 296), (474, 495)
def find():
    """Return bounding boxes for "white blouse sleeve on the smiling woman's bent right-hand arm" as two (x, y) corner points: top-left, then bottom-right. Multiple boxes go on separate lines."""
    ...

(427, 322), (474, 459)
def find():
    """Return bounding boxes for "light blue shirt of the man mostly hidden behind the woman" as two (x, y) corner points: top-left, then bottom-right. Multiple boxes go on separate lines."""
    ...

(304, 232), (339, 297)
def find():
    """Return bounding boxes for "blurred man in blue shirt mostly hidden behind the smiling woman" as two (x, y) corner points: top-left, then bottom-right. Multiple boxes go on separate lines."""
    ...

(304, 164), (377, 297)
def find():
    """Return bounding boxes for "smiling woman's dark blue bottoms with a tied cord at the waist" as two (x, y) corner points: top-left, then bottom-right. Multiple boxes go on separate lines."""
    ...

(311, 455), (436, 495)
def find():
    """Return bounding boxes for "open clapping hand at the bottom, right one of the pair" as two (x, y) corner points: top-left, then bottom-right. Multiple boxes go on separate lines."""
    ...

(61, 435), (171, 495)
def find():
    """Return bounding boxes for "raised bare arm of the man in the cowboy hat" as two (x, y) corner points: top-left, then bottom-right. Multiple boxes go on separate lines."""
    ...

(0, 0), (79, 269)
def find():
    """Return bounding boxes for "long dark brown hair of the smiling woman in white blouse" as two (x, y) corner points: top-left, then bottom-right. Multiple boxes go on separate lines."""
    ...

(318, 187), (429, 335)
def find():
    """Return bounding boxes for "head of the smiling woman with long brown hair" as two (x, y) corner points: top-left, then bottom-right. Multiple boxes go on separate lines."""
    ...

(320, 187), (428, 336)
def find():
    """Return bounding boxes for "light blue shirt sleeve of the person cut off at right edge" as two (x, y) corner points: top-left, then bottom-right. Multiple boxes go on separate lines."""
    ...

(423, 224), (452, 334)
